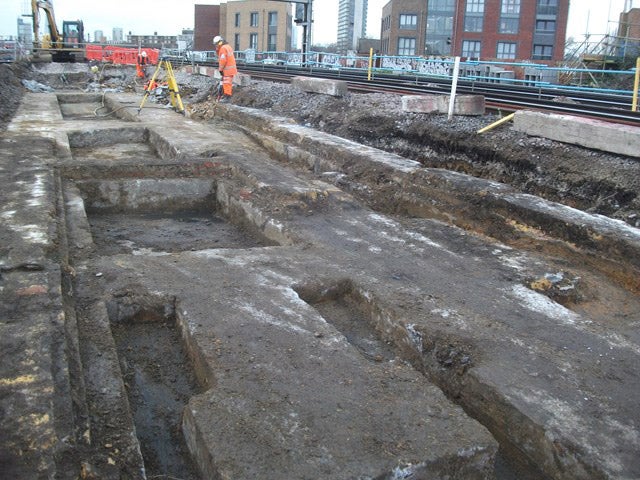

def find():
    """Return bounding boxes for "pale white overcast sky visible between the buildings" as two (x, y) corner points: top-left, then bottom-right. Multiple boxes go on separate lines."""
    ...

(0, 0), (640, 44)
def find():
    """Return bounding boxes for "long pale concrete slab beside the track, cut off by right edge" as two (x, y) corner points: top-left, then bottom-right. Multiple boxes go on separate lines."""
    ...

(513, 110), (640, 157)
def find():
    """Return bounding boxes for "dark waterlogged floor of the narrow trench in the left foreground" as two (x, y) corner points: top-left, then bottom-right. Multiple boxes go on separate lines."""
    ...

(112, 298), (200, 480)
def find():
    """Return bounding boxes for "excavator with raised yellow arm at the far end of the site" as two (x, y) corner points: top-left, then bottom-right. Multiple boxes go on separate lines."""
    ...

(31, 0), (85, 62)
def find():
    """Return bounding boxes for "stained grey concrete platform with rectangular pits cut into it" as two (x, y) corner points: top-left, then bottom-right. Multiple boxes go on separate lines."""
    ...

(0, 94), (640, 479)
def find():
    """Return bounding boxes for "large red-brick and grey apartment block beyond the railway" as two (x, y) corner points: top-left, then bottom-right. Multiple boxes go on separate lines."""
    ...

(380, 0), (569, 61)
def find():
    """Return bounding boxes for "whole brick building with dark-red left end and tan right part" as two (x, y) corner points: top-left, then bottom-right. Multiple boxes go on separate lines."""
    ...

(194, 0), (293, 52)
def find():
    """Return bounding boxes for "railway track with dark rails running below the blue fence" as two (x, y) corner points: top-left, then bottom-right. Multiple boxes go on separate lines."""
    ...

(228, 65), (640, 126)
